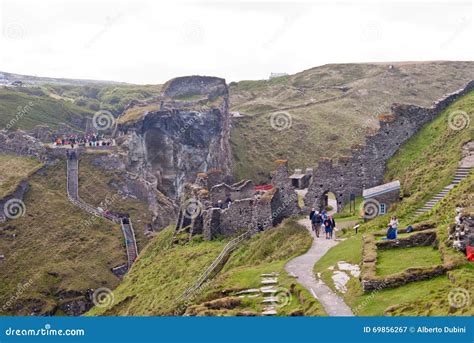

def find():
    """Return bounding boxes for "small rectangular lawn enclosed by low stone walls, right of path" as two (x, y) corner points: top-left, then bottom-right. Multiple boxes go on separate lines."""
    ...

(377, 246), (443, 276)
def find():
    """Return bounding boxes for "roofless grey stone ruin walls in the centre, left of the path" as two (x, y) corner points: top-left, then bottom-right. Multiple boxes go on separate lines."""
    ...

(176, 161), (300, 240)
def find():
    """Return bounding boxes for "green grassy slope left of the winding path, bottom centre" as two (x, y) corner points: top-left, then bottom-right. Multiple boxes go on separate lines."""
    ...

(89, 221), (324, 316)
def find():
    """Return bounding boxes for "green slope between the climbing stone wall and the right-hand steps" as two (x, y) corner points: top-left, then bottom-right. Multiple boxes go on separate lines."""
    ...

(385, 92), (474, 217)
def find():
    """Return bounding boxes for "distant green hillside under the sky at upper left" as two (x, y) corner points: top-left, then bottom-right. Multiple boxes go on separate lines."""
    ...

(0, 84), (161, 135)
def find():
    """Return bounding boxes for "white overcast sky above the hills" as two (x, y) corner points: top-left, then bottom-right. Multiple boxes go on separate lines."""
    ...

(0, 0), (474, 84)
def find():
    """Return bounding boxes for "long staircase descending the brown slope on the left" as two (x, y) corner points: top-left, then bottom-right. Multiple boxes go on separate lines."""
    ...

(67, 153), (138, 270)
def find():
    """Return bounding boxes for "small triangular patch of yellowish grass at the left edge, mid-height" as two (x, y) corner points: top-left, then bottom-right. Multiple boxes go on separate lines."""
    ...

(0, 155), (43, 198)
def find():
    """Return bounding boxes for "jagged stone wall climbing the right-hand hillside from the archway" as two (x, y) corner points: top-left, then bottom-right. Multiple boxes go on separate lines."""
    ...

(305, 81), (474, 211)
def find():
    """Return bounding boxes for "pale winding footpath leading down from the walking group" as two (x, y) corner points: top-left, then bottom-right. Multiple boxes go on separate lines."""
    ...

(285, 218), (353, 316)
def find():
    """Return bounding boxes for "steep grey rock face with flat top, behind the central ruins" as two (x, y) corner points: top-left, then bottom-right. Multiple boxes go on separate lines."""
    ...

(119, 76), (232, 199)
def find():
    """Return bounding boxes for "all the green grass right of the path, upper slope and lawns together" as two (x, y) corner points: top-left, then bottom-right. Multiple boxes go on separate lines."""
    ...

(315, 92), (474, 315)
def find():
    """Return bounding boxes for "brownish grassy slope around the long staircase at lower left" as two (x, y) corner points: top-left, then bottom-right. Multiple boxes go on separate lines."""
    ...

(0, 156), (150, 315)
